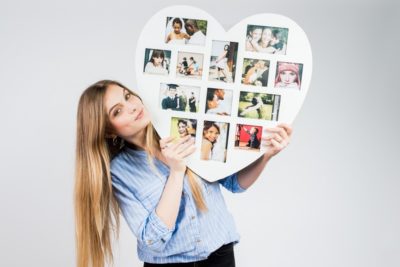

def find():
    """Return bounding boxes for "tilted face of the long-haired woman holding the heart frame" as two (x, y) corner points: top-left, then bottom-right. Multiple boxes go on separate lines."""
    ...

(104, 85), (150, 140)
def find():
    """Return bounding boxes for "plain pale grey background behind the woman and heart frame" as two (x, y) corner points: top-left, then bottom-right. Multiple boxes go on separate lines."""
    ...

(0, 0), (400, 267)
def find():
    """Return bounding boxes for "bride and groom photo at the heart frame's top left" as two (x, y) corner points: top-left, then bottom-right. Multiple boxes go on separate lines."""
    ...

(165, 17), (207, 45)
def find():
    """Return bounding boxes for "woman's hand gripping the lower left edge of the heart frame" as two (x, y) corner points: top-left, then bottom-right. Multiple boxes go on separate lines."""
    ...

(160, 135), (196, 172)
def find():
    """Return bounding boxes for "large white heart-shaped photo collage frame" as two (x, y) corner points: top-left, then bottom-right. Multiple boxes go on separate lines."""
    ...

(135, 6), (312, 182)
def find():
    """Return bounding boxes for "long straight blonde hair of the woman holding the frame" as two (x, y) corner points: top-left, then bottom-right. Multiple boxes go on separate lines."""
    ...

(74, 80), (207, 267)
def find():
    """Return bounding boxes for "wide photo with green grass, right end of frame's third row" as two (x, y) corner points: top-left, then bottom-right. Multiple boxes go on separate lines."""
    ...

(238, 92), (281, 121)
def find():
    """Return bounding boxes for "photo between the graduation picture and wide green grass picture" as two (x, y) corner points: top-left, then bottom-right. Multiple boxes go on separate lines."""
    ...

(205, 88), (233, 116)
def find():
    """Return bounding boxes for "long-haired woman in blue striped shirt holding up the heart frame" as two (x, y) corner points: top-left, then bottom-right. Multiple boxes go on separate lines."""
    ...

(75, 80), (292, 267)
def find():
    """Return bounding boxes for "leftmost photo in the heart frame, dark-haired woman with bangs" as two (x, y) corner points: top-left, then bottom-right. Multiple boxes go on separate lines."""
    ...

(143, 48), (171, 75)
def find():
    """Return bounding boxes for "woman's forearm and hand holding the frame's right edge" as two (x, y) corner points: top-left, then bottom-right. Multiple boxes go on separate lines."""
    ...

(238, 124), (293, 189)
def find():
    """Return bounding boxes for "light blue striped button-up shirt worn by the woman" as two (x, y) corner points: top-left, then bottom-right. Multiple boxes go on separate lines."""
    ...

(111, 147), (244, 263)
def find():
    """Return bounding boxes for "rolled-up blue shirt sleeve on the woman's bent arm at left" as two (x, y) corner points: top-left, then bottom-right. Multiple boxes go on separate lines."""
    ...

(112, 177), (175, 253)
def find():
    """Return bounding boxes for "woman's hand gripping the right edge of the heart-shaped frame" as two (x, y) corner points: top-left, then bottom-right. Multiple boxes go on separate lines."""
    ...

(262, 123), (293, 158)
